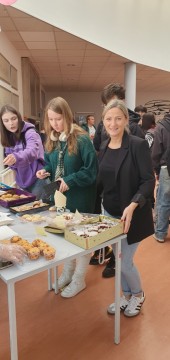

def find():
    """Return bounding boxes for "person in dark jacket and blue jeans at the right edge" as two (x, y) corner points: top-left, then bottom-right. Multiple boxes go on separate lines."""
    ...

(151, 114), (170, 243)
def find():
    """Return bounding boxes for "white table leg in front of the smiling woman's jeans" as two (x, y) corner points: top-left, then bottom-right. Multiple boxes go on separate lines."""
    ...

(114, 240), (121, 344)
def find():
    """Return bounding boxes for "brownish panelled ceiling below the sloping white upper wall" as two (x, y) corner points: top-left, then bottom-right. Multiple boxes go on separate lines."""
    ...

(0, 5), (170, 93)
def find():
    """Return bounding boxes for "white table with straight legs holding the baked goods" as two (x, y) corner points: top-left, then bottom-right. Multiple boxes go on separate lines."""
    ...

(0, 218), (126, 360)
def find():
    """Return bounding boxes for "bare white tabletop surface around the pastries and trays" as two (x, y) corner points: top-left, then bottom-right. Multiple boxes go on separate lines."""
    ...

(0, 208), (123, 283)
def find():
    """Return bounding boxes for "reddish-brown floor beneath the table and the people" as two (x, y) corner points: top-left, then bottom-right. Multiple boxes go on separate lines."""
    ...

(0, 229), (170, 360)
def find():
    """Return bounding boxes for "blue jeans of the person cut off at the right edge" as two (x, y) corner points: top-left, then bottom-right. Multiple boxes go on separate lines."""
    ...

(155, 168), (170, 239)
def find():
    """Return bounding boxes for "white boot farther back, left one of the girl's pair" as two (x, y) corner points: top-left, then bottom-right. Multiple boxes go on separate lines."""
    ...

(52, 260), (76, 290)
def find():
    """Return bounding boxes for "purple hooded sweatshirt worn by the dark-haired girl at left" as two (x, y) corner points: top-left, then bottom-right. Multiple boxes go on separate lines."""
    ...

(5, 122), (44, 188)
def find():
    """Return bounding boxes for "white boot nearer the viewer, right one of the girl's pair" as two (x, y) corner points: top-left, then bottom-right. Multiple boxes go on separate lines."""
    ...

(61, 254), (91, 298)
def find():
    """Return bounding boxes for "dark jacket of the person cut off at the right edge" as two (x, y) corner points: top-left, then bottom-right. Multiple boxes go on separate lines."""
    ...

(152, 114), (170, 175)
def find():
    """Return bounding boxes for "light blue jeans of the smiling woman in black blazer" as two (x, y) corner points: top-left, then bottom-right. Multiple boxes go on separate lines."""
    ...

(104, 210), (142, 296)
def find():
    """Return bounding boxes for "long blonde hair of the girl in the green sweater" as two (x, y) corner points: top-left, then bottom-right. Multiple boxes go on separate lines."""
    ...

(44, 97), (87, 154)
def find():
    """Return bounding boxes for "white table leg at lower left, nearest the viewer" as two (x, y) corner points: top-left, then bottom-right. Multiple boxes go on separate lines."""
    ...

(7, 283), (18, 360)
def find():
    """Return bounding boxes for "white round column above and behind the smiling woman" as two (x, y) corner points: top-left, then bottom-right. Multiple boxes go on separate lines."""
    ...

(124, 62), (136, 110)
